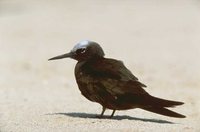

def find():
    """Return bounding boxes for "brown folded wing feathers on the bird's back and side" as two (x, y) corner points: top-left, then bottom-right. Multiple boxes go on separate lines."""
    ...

(85, 59), (146, 95)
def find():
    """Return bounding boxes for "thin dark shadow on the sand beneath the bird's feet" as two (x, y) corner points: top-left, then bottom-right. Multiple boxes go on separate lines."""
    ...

(47, 112), (175, 124)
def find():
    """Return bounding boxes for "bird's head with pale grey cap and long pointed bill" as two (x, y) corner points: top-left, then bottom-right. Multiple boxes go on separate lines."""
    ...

(49, 40), (104, 61)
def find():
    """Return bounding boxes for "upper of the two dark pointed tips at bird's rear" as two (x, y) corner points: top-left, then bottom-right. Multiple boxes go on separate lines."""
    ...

(147, 96), (184, 107)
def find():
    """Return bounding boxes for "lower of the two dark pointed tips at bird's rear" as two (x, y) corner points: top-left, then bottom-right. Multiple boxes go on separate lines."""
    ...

(142, 107), (186, 118)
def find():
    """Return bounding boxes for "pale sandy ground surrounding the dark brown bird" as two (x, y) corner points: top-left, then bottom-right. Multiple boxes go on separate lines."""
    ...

(0, 0), (200, 132)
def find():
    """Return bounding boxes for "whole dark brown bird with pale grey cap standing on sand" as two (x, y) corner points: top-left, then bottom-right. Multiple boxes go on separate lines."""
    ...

(49, 40), (186, 118)
